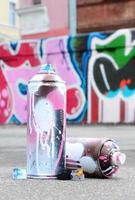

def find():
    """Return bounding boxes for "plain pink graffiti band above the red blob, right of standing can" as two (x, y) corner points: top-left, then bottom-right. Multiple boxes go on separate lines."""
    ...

(44, 39), (78, 86)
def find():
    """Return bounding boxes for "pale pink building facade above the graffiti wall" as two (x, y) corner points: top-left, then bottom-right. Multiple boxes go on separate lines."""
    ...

(20, 0), (69, 39)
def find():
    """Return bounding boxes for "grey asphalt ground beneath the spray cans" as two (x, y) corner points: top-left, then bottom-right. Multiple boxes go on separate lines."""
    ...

(0, 125), (135, 200)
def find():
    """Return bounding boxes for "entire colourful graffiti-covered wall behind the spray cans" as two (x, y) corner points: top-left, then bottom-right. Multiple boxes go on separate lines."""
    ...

(0, 29), (135, 124)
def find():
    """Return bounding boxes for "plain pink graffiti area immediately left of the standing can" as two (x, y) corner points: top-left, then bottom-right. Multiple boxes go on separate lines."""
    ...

(5, 62), (39, 123)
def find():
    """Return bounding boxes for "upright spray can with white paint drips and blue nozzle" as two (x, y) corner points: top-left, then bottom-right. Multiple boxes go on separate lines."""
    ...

(27, 64), (66, 179)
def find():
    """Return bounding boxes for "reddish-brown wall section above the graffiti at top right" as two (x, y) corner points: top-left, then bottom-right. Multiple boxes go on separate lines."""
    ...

(77, 0), (135, 33)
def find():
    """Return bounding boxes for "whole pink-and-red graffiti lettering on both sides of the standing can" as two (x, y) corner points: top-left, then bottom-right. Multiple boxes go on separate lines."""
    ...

(0, 38), (86, 123)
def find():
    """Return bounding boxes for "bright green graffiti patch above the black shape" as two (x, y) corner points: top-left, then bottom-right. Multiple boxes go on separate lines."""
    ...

(96, 33), (135, 69)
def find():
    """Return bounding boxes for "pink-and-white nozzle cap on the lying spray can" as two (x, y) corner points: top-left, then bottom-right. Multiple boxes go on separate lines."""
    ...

(111, 151), (126, 166)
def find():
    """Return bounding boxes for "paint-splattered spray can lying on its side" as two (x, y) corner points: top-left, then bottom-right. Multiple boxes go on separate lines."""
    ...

(66, 138), (126, 178)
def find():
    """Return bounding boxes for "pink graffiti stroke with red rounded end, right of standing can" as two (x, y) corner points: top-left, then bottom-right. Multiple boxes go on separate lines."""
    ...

(44, 38), (85, 119)
